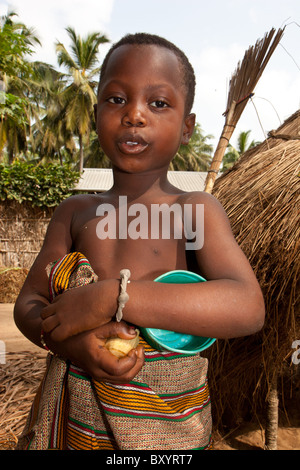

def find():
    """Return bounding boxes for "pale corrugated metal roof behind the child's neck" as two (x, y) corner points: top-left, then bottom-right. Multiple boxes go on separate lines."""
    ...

(75, 168), (211, 192)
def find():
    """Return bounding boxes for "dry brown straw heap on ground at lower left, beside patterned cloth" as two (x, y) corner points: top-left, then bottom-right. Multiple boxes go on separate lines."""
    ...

(0, 352), (46, 450)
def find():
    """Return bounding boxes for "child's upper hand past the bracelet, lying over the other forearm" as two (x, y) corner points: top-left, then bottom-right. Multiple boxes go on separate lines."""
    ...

(41, 280), (118, 341)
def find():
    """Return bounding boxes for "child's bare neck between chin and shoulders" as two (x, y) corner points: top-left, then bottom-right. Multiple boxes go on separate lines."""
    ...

(110, 168), (174, 200)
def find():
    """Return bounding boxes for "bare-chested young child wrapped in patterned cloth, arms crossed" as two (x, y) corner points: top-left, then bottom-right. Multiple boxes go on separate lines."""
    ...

(15, 34), (264, 450)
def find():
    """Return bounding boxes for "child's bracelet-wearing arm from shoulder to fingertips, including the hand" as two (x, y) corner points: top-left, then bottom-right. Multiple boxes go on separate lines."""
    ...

(42, 194), (264, 341)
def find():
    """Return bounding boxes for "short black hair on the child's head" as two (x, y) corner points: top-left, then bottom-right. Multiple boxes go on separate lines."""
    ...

(99, 33), (196, 114)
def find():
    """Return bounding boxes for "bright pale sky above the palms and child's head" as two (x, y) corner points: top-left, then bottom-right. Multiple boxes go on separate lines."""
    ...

(0, 0), (300, 151)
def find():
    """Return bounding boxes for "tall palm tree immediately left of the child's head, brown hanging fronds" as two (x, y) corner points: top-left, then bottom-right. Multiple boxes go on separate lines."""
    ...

(56, 27), (108, 172)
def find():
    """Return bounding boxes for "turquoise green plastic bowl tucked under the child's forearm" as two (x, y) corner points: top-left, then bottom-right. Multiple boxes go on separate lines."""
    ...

(140, 270), (216, 355)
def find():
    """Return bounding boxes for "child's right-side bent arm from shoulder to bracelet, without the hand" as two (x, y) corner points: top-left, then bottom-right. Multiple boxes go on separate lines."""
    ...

(124, 193), (265, 338)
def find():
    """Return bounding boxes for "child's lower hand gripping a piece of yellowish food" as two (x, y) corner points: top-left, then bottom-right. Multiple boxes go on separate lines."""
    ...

(51, 322), (144, 384)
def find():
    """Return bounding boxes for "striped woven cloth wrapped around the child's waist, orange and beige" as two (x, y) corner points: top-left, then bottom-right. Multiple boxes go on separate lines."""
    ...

(17, 252), (211, 450)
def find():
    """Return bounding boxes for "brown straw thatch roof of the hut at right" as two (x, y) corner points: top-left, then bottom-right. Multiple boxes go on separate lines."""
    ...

(207, 111), (300, 430)
